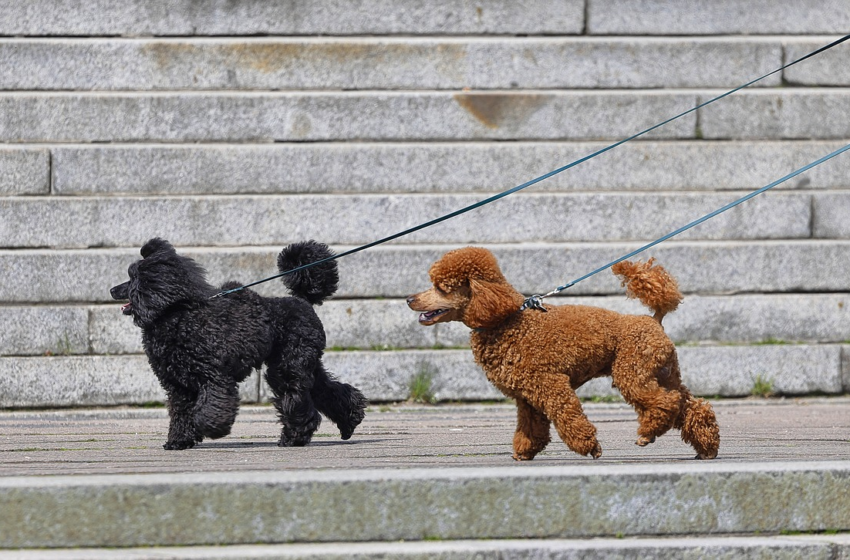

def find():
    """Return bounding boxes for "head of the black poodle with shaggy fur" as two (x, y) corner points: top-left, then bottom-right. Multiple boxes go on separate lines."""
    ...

(109, 237), (215, 327)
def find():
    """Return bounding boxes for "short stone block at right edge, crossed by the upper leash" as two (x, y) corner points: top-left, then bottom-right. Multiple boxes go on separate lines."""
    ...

(783, 37), (850, 86)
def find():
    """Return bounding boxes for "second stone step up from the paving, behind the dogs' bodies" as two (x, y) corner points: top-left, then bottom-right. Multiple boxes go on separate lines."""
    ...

(0, 293), (850, 356)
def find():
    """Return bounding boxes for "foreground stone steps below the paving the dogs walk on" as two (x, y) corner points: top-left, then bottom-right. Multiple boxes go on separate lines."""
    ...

(0, 462), (850, 560)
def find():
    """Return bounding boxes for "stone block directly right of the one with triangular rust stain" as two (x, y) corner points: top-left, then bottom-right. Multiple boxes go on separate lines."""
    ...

(700, 88), (850, 140)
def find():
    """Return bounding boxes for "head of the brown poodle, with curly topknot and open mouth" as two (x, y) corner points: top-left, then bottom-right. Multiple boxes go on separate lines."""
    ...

(407, 247), (525, 329)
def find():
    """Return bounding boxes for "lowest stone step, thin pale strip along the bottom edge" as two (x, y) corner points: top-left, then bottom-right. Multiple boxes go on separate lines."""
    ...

(0, 533), (850, 560)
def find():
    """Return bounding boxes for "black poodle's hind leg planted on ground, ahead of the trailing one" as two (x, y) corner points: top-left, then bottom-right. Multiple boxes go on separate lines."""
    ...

(266, 362), (322, 447)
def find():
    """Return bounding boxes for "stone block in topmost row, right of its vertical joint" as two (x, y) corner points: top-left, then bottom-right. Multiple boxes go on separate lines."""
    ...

(587, 0), (850, 35)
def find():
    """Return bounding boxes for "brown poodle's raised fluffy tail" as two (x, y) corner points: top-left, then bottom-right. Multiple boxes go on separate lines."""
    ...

(611, 259), (682, 323)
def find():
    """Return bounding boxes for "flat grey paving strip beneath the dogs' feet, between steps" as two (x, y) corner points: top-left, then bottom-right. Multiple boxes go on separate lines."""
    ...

(0, 397), (850, 476)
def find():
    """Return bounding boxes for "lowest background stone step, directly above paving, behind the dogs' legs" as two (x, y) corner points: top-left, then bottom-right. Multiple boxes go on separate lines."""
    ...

(0, 344), (850, 408)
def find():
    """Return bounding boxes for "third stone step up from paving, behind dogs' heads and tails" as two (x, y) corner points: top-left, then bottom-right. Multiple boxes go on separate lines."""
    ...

(0, 239), (850, 304)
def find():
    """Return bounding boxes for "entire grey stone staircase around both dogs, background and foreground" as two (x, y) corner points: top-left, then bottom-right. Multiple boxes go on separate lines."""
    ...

(0, 0), (850, 560)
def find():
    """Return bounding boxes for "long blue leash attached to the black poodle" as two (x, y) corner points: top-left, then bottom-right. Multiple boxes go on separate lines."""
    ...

(212, 34), (850, 298)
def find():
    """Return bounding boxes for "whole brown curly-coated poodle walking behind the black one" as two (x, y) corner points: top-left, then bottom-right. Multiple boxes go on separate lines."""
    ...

(407, 247), (720, 460)
